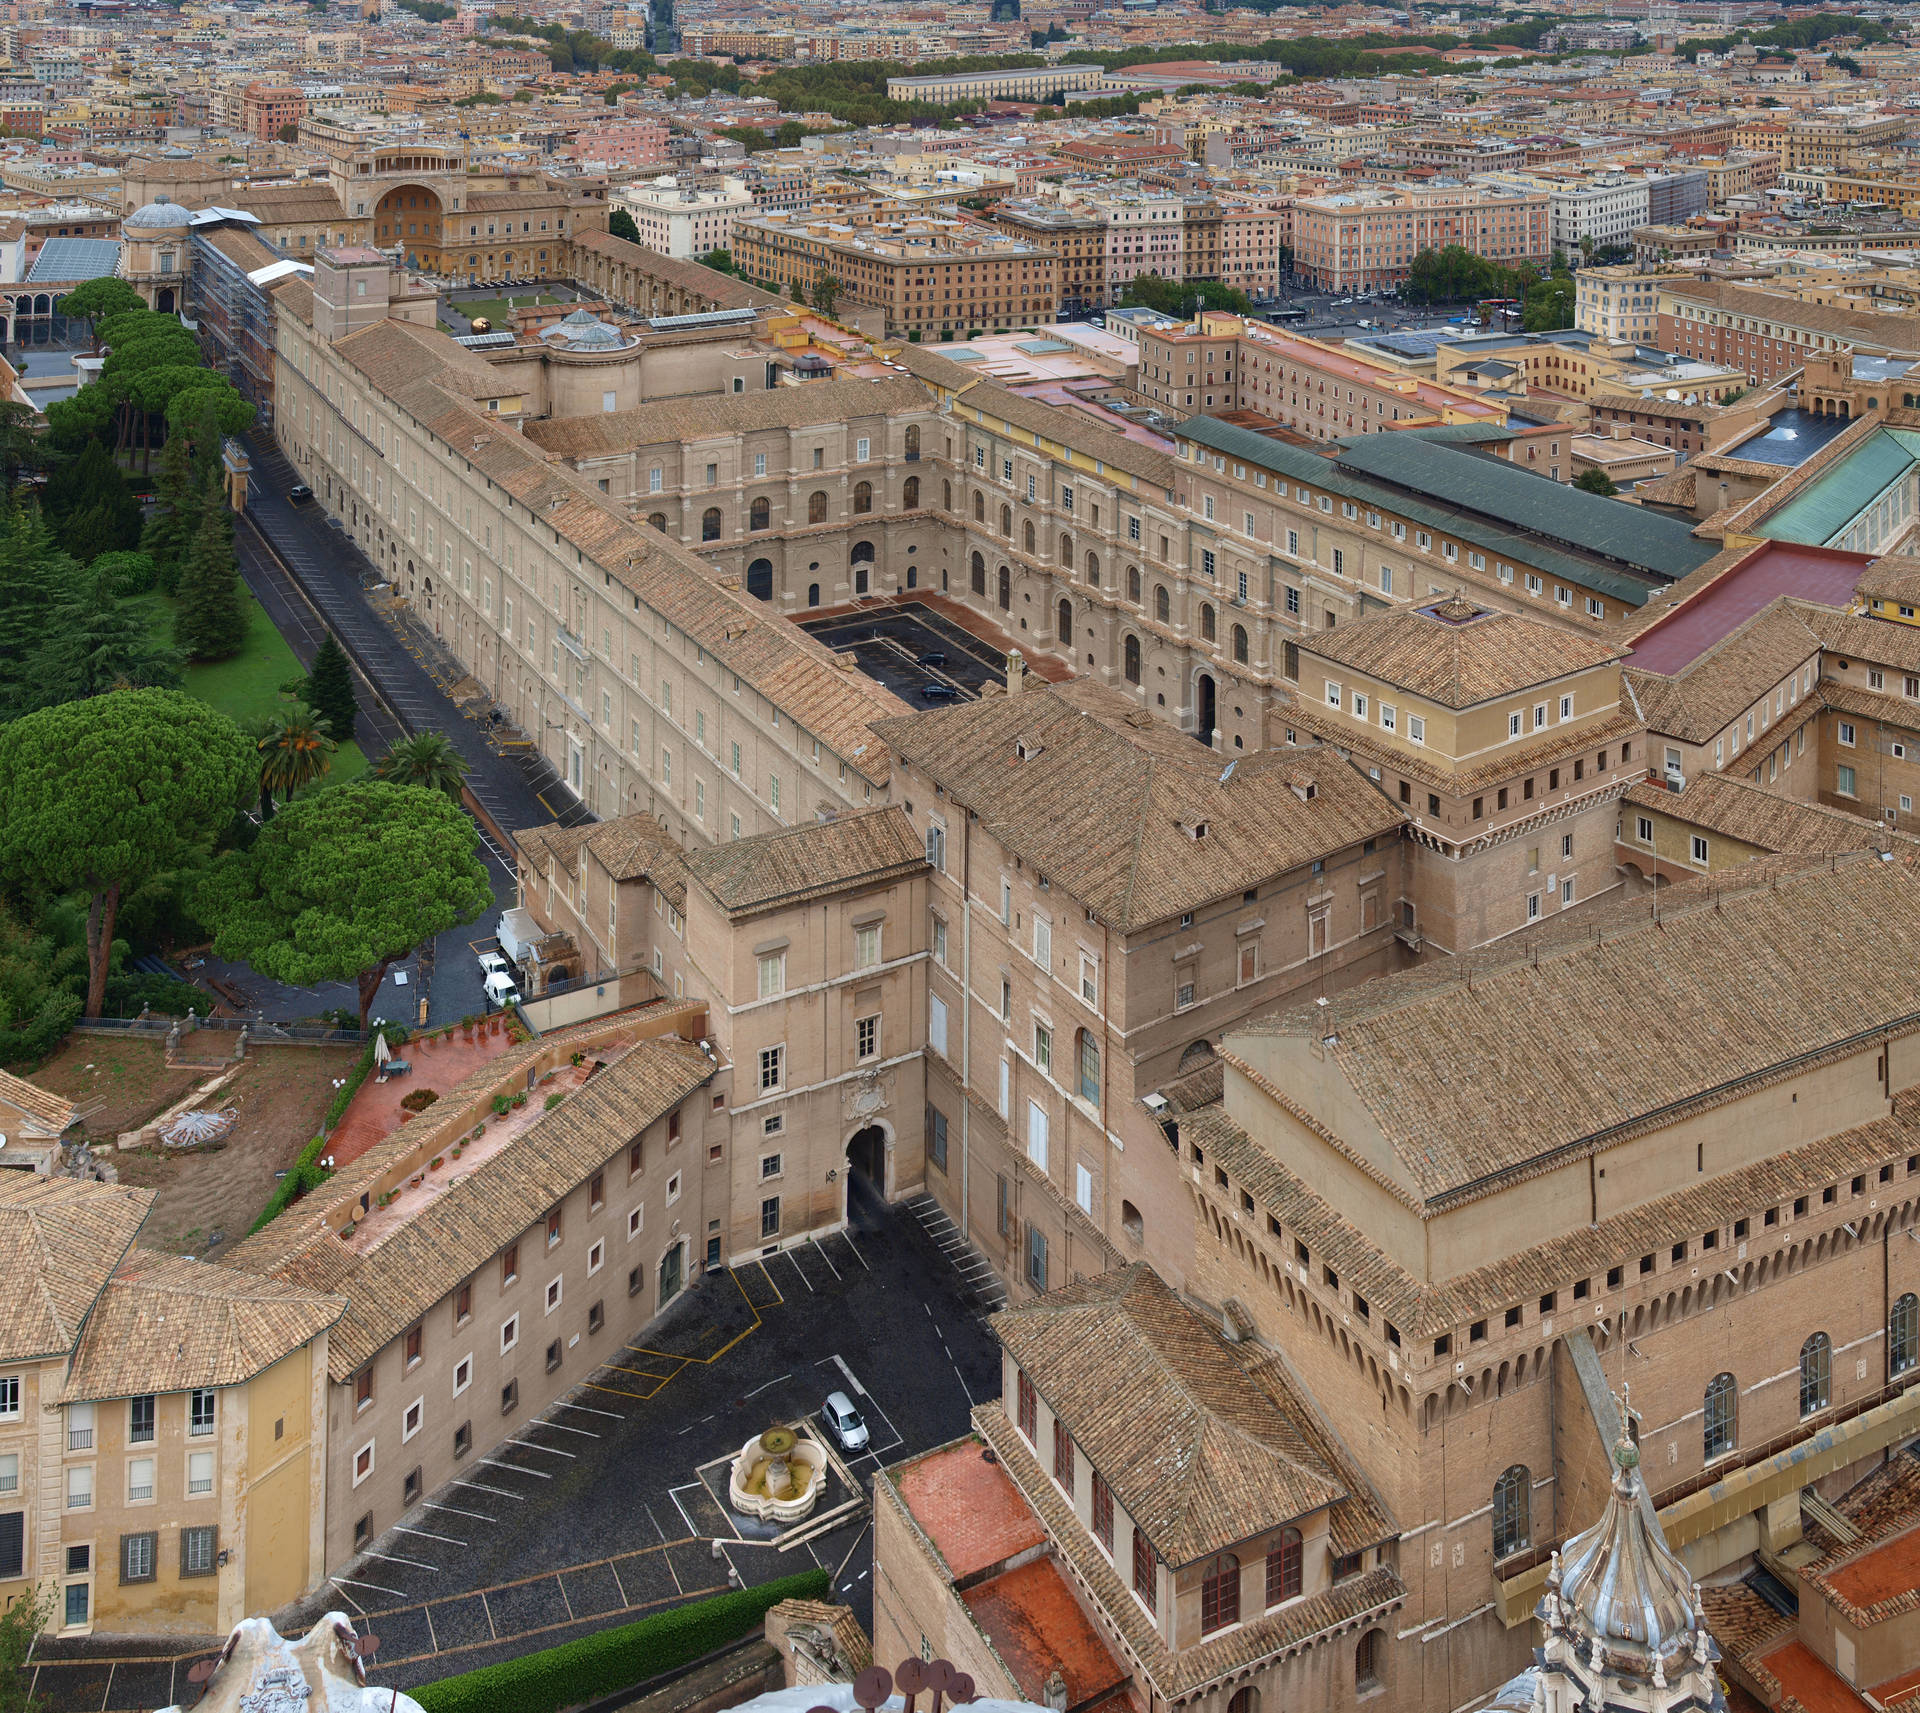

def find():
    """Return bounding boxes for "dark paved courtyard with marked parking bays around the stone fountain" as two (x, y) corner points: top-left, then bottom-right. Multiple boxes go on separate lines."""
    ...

(18, 1198), (1000, 1713)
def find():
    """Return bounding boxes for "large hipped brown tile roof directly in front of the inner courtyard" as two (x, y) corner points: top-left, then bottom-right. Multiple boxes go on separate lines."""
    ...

(876, 680), (1404, 931)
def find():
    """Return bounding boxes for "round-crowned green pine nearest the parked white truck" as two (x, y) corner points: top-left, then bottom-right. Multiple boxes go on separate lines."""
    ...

(198, 780), (493, 1027)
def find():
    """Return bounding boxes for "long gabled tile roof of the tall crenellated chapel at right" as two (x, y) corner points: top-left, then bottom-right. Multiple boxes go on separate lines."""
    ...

(1225, 855), (1920, 1202)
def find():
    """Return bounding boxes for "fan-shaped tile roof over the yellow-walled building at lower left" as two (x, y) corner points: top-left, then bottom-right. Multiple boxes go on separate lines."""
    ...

(61, 1248), (346, 1404)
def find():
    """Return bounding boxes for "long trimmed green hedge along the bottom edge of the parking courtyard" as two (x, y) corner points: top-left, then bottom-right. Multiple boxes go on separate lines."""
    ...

(411, 1571), (831, 1713)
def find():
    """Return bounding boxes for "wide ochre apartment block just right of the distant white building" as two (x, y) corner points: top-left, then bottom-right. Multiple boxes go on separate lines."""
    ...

(733, 213), (1060, 338)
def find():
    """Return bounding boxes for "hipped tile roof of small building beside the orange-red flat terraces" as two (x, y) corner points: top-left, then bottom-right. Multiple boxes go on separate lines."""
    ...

(993, 1262), (1346, 1565)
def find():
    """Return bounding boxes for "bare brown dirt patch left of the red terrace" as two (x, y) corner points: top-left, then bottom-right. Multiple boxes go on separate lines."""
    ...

(111, 1047), (359, 1260)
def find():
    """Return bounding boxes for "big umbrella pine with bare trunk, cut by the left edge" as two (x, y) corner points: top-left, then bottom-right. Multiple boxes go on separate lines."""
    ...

(0, 689), (253, 1016)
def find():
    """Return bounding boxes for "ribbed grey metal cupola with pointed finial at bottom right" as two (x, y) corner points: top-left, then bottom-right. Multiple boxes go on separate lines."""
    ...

(1548, 1438), (1701, 1678)
